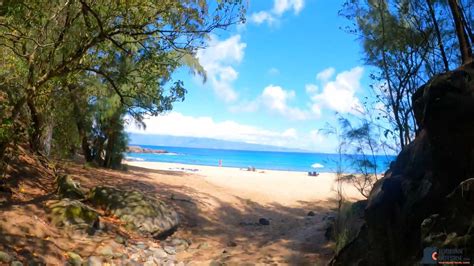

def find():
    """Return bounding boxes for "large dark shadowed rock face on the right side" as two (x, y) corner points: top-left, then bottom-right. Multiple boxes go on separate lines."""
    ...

(331, 68), (474, 265)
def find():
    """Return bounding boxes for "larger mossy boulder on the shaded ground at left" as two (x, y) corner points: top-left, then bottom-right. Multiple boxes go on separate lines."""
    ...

(88, 186), (179, 238)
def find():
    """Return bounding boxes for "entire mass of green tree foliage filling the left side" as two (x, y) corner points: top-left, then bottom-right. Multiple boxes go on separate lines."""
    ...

(0, 0), (245, 167)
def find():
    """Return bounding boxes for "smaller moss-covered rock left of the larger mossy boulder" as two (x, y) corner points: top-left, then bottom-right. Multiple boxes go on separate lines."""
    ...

(48, 199), (99, 228)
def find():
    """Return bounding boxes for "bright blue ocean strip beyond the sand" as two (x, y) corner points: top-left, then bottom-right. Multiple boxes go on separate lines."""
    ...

(126, 145), (395, 173)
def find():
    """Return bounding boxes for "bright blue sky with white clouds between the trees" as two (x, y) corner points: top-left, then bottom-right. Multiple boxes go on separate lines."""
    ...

(126, 0), (370, 153)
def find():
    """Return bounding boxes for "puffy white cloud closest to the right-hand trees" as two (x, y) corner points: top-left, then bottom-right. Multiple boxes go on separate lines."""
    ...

(310, 66), (364, 114)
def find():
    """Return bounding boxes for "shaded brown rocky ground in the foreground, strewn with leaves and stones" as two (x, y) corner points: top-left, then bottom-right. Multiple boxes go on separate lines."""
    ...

(0, 149), (333, 265)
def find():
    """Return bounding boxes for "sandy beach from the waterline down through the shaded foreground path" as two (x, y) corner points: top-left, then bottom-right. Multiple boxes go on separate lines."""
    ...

(122, 161), (358, 265)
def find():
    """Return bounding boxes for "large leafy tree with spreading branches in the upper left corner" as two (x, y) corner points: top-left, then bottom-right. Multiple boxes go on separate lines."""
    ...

(0, 0), (244, 153)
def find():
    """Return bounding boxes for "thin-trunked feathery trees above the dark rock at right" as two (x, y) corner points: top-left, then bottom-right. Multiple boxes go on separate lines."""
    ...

(341, 0), (470, 150)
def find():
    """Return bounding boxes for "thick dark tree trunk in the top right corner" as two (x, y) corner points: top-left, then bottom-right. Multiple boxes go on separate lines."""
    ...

(448, 0), (472, 65)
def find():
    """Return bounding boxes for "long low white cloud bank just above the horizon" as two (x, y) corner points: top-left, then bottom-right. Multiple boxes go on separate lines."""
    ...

(126, 112), (298, 147)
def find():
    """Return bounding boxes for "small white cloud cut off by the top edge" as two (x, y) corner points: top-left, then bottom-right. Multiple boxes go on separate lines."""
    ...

(250, 0), (304, 25)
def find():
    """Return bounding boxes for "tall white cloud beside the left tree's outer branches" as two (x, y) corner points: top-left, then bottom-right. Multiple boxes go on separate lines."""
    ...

(197, 35), (247, 102)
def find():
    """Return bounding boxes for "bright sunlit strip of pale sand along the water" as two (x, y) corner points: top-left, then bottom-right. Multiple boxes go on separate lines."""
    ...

(126, 161), (360, 205)
